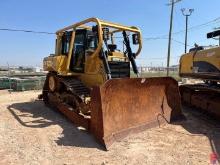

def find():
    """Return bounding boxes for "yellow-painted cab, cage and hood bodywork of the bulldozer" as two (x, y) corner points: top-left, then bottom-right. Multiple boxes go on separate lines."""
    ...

(43, 18), (142, 87)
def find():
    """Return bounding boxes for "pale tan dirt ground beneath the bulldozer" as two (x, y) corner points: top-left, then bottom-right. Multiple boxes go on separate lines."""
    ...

(0, 91), (220, 165)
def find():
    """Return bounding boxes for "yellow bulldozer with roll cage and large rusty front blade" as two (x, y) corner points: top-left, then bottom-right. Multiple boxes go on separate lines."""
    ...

(40, 18), (181, 149)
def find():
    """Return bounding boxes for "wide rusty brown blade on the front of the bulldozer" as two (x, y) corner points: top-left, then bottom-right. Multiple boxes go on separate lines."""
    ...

(90, 77), (182, 149)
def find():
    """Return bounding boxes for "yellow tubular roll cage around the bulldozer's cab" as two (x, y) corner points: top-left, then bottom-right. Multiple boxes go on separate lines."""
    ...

(56, 18), (142, 78)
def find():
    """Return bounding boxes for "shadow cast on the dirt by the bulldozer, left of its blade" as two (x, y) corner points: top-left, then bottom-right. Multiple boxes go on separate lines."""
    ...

(8, 100), (105, 150)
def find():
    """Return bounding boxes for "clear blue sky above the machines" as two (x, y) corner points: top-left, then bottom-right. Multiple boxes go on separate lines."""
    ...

(0, 0), (220, 66)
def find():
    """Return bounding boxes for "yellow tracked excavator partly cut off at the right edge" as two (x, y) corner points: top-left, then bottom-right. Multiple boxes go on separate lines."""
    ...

(180, 30), (220, 117)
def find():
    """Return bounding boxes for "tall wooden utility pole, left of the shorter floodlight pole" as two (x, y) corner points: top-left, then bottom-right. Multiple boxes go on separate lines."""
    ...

(167, 0), (181, 76)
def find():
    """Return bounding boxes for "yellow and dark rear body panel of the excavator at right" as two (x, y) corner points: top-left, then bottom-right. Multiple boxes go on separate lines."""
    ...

(180, 47), (220, 80)
